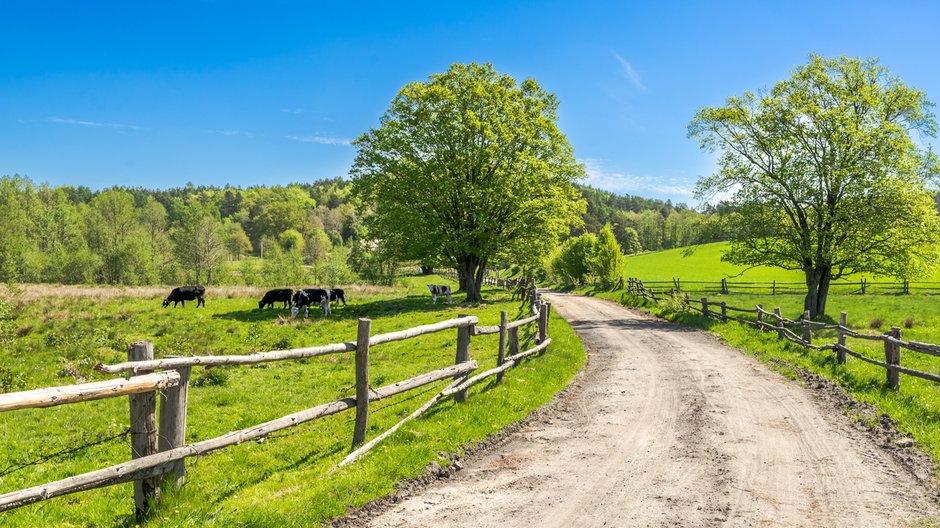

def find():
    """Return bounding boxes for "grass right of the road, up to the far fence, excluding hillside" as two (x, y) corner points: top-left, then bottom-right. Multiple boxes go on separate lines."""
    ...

(596, 284), (940, 462)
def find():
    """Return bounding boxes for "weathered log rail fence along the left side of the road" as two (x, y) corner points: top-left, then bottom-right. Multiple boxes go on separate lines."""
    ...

(0, 294), (552, 518)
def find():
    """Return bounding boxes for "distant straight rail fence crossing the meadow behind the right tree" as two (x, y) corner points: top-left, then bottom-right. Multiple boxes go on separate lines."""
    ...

(628, 277), (940, 295)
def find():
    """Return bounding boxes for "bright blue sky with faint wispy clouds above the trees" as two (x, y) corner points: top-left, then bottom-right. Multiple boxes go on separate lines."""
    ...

(0, 0), (940, 203)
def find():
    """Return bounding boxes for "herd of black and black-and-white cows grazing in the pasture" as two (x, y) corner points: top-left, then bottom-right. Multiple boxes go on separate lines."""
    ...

(163, 284), (451, 318)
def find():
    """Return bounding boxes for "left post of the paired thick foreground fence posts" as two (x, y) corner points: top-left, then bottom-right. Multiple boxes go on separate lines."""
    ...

(127, 341), (160, 520)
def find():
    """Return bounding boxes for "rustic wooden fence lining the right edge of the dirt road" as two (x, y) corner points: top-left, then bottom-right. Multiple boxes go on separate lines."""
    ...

(627, 279), (940, 390)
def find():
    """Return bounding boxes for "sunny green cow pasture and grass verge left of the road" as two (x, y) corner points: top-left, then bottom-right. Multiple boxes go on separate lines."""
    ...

(0, 276), (585, 527)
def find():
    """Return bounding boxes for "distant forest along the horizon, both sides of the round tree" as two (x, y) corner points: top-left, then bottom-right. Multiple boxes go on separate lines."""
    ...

(0, 176), (714, 286)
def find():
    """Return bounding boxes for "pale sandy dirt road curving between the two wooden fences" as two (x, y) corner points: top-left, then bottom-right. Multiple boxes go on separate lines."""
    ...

(369, 294), (937, 528)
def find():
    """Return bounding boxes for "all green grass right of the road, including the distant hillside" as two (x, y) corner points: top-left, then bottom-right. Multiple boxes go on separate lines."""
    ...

(588, 243), (940, 462)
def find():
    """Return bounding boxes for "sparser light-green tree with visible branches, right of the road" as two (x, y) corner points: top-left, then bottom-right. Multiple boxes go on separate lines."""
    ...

(689, 55), (940, 315)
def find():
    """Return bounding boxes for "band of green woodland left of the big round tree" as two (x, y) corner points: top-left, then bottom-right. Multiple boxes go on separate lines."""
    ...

(0, 176), (363, 285)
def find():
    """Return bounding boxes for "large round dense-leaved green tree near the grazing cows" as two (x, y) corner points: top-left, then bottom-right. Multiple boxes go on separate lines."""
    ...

(351, 63), (584, 302)
